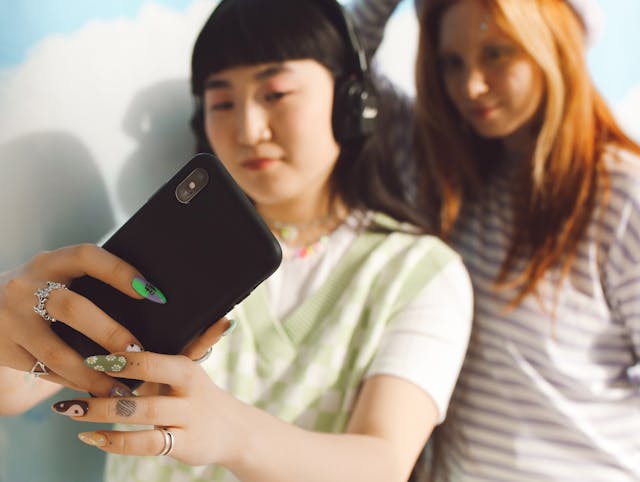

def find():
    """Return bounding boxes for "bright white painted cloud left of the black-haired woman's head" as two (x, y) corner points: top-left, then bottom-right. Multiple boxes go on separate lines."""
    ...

(0, 0), (215, 218)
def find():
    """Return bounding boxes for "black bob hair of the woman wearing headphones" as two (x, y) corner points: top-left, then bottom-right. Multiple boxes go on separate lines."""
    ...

(191, 0), (426, 230)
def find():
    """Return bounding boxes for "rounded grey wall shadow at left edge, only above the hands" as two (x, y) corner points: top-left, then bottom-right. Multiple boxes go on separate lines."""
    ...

(0, 132), (114, 271)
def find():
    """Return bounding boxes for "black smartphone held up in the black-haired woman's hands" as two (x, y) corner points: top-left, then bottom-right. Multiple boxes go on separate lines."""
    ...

(52, 154), (282, 389)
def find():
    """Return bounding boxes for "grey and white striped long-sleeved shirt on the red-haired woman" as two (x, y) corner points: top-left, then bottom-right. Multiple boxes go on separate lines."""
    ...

(351, 0), (640, 482)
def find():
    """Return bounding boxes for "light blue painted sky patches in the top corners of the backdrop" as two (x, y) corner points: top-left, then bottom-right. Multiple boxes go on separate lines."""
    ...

(0, 0), (640, 104)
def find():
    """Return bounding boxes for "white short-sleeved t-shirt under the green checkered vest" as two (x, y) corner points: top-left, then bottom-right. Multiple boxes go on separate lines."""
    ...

(266, 215), (473, 422)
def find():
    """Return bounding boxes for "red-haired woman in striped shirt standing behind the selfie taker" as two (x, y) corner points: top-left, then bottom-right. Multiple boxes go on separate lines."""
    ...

(356, 0), (640, 481)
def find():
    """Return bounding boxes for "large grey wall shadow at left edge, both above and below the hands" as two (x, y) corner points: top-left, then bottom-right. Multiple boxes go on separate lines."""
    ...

(0, 132), (114, 482)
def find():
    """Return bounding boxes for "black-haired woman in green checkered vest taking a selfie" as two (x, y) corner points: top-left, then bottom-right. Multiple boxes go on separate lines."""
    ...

(0, 0), (472, 482)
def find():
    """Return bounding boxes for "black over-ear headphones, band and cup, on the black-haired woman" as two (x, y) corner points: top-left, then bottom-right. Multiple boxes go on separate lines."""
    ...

(316, 0), (378, 142)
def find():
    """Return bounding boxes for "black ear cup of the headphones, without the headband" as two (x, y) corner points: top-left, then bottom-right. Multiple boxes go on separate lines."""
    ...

(332, 79), (378, 142)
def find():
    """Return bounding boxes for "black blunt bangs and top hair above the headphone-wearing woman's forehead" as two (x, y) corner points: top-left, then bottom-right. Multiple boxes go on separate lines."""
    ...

(191, 0), (348, 96)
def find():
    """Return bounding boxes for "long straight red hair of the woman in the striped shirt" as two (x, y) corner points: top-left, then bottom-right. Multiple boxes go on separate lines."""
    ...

(416, 0), (640, 306)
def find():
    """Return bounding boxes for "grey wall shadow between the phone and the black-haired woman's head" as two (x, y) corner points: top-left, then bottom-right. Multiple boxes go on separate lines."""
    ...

(116, 79), (195, 217)
